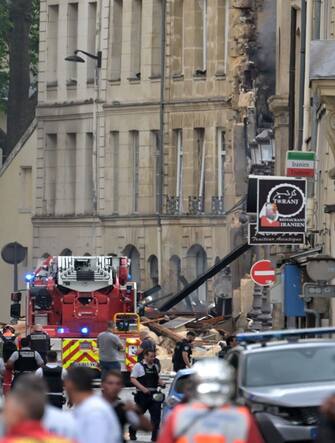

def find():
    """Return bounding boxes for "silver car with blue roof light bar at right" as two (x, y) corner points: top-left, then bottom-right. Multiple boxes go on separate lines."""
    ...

(226, 328), (335, 443)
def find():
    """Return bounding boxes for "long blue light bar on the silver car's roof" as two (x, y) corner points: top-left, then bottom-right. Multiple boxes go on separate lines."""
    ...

(236, 327), (335, 343)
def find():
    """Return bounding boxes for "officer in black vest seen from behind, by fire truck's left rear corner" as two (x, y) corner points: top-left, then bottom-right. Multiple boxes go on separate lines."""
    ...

(6, 337), (44, 386)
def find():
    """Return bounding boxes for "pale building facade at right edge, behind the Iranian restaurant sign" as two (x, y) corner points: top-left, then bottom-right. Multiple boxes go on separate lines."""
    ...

(270, 0), (335, 325)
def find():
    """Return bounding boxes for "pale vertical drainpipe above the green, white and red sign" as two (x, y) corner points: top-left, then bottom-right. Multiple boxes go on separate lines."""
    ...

(302, 0), (313, 151)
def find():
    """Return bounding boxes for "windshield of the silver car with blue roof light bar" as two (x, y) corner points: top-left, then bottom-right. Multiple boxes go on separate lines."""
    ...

(243, 345), (335, 387)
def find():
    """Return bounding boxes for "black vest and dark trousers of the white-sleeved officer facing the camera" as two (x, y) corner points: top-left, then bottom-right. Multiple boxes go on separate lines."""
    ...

(129, 363), (162, 441)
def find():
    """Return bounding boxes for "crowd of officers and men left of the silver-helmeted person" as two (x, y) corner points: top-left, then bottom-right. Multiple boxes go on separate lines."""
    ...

(0, 322), (252, 443)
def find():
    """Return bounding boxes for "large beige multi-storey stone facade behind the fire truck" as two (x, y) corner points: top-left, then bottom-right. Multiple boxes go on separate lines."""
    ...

(33, 0), (273, 312)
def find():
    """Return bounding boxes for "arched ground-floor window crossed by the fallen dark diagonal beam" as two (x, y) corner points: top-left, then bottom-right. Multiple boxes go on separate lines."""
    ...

(187, 245), (207, 310)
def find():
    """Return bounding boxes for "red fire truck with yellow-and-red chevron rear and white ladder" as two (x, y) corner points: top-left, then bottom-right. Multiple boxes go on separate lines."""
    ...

(12, 256), (140, 372)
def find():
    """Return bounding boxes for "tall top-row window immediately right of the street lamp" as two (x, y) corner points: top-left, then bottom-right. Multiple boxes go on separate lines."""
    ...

(111, 0), (123, 80)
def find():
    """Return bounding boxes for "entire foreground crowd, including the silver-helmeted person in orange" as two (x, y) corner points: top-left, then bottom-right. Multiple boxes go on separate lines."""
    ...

(9, 323), (335, 443)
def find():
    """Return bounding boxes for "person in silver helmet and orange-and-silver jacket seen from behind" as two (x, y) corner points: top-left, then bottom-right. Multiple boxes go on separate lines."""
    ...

(158, 359), (264, 443)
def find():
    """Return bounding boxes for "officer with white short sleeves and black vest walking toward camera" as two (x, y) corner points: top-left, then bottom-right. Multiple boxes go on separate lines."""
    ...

(129, 350), (164, 441)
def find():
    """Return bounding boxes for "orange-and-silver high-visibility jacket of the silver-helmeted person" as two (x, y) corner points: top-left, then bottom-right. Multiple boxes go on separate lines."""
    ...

(158, 403), (264, 443)
